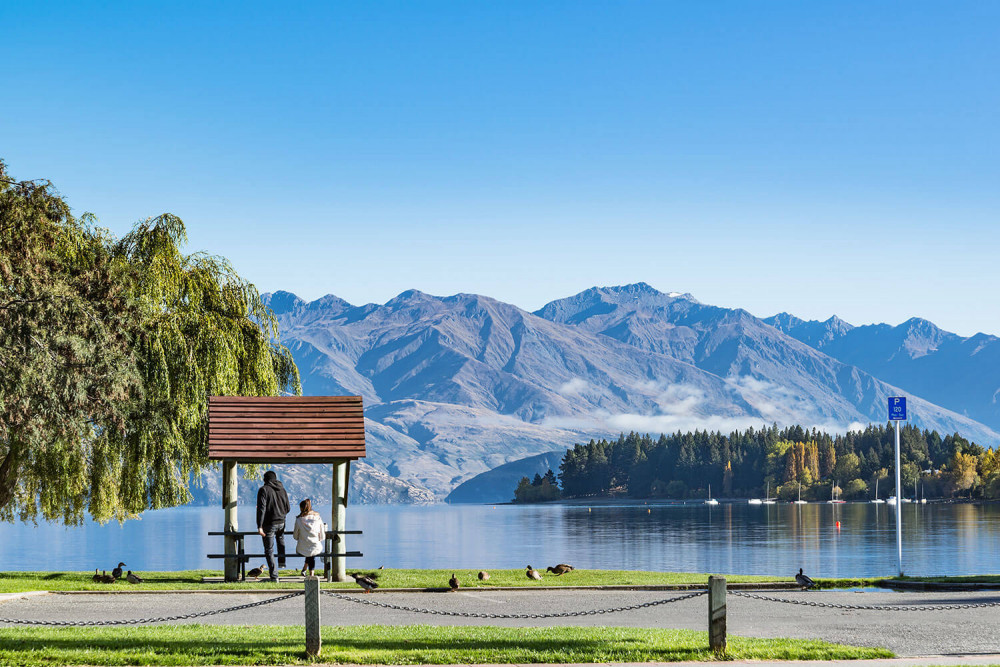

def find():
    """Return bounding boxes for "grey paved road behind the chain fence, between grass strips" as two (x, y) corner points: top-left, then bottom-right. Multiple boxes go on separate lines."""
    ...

(0, 590), (1000, 656)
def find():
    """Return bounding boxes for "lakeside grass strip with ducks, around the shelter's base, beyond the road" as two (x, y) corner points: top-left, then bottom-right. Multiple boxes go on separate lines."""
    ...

(0, 566), (792, 593)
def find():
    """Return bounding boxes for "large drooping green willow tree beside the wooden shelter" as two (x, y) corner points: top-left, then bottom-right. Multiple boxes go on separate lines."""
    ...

(0, 163), (299, 523)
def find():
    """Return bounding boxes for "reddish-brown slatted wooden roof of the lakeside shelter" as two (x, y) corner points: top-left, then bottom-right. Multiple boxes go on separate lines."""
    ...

(208, 396), (365, 463)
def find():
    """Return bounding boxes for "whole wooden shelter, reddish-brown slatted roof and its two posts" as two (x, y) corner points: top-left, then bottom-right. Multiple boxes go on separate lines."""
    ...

(208, 396), (365, 581)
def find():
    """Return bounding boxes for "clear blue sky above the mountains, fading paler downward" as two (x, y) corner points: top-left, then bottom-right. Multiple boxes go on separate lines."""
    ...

(0, 0), (1000, 335)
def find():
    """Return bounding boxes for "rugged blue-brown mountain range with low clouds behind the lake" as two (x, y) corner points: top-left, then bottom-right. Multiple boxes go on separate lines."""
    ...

(207, 283), (1000, 502)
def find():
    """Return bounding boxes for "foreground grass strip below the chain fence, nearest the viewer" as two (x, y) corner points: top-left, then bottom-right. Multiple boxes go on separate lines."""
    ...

(0, 625), (893, 666)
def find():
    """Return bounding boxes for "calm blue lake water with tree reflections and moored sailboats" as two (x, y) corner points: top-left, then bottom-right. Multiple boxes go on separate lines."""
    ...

(0, 502), (1000, 577)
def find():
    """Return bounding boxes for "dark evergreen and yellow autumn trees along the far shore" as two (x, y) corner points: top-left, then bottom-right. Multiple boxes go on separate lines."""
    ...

(514, 425), (1000, 502)
